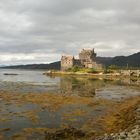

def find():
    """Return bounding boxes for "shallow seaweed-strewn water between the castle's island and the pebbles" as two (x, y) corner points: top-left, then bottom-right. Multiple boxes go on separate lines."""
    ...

(0, 70), (140, 140)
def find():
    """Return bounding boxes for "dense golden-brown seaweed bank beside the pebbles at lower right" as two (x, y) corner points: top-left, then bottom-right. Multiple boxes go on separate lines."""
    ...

(100, 96), (140, 133)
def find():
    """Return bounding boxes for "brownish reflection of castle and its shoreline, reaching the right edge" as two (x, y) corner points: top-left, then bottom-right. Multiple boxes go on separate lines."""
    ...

(59, 76), (140, 97)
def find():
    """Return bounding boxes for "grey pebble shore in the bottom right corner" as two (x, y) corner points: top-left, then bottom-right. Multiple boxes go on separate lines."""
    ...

(91, 105), (140, 140)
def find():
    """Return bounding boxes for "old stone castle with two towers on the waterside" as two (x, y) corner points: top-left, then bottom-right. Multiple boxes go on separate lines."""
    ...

(61, 49), (103, 71)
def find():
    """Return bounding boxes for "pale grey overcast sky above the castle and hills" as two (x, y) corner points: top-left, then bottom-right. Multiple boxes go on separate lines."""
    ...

(0, 0), (140, 65)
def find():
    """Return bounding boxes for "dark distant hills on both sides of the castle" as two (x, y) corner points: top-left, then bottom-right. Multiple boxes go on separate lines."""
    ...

(1, 52), (140, 70)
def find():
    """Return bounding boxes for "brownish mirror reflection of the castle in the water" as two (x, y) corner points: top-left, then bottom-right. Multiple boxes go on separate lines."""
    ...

(60, 77), (102, 97)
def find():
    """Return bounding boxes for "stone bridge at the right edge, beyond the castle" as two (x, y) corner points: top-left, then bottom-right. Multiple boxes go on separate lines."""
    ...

(120, 70), (140, 77)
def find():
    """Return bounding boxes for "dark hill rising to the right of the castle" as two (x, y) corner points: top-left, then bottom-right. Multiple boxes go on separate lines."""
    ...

(97, 52), (140, 67)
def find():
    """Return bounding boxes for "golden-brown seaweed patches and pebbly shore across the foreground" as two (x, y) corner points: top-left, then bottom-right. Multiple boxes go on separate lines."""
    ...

(0, 89), (140, 140)
